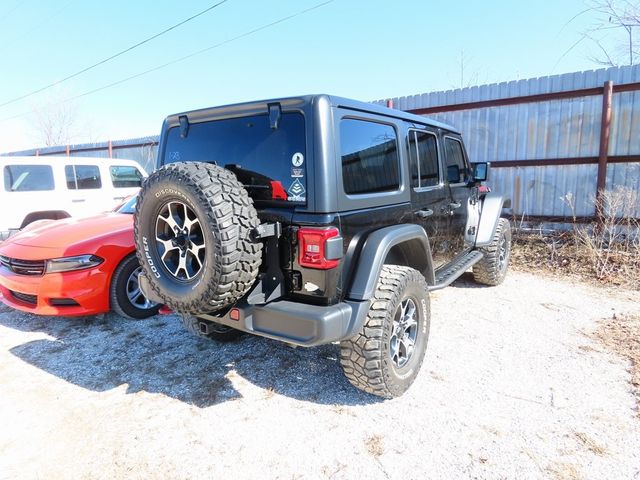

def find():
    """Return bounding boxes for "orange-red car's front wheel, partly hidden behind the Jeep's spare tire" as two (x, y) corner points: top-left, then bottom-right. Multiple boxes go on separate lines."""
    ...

(109, 254), (160, 320)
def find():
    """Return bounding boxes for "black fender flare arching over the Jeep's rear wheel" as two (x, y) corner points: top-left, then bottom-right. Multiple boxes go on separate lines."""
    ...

(346, 224), (435, 301)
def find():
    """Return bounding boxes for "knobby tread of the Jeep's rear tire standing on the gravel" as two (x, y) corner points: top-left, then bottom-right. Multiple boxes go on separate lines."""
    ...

(340, 265), (430, 398)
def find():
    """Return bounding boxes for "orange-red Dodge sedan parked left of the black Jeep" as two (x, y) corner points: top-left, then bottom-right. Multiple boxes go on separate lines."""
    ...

(0, 197), (159, 319)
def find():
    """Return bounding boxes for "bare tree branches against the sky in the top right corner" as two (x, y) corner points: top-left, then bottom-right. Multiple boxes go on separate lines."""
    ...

(582, 0), (640, 67)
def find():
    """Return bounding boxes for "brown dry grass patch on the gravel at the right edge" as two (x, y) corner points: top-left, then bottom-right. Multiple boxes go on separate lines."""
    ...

(593, 314), (640, 416)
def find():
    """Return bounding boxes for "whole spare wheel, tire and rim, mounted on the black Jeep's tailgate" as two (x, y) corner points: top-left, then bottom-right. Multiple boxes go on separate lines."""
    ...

(134, 162), (262, 313)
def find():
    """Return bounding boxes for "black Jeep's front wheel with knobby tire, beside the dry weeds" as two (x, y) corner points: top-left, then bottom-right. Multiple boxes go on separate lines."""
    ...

(473, 218), (511, 286)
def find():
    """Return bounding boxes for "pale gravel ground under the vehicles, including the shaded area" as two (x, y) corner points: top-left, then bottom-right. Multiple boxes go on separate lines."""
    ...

(0, 272), (640, 479)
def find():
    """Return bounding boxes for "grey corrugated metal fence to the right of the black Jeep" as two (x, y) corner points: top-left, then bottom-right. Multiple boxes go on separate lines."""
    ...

(378, 65), (640, 219)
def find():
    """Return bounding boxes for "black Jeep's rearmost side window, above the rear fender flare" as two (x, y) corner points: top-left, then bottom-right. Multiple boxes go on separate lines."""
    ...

(340, 118), (400, 194)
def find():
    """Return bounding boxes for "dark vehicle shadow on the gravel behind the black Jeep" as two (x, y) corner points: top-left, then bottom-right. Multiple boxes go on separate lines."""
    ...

(0, 310), (383, 408)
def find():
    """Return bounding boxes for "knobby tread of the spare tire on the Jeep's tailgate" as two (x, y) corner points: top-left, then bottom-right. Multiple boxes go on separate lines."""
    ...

(134, 162), (262, 312)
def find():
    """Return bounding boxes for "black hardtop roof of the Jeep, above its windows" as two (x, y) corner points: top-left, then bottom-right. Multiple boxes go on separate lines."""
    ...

(166, 94), (460, 133)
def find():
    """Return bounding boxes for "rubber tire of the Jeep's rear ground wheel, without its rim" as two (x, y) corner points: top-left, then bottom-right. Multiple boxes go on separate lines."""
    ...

(340, 265), (431, 398)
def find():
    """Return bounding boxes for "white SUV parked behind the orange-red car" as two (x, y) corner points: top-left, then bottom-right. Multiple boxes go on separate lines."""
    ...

(0, 156), (147, 241)
